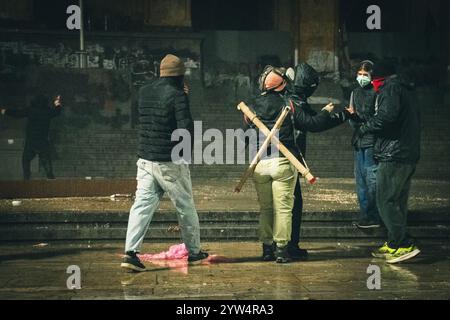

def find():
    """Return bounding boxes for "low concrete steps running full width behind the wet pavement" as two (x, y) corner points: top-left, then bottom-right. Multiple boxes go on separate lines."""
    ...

(0, 211), (450, 241)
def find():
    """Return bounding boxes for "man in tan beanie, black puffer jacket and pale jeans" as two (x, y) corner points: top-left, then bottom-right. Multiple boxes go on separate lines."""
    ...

(121, 54), (208, 271)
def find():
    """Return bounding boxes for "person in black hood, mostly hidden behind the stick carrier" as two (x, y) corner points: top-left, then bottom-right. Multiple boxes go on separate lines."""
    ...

(285, 62), (348, 259)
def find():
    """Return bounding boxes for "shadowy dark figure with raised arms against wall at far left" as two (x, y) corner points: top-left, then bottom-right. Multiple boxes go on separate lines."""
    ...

(1, 94), (62, 180)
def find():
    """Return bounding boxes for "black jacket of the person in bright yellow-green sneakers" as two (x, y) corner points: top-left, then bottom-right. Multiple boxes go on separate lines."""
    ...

(359, 76), (421, 164)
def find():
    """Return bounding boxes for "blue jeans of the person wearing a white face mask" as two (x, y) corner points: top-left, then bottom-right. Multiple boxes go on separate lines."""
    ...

(354, 148), (380, 222)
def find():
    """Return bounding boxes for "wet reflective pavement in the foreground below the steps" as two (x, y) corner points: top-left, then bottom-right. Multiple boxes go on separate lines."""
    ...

(0, 241), (450, 300)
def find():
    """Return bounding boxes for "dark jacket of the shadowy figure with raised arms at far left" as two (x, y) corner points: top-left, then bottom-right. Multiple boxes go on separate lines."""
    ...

(5, 95), (62, 147)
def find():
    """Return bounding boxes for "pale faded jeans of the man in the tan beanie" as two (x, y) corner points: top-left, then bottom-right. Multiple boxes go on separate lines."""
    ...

(125, 159), (200, 254)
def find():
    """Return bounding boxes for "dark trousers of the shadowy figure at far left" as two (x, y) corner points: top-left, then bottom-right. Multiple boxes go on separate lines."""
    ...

(22, 141), (55, 180)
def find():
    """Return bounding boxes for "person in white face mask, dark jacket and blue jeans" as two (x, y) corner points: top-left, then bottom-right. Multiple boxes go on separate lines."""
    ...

(349, 60), (380, 229)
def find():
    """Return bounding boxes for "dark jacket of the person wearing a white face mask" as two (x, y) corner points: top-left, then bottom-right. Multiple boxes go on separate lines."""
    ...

(350, 85), (376, 150)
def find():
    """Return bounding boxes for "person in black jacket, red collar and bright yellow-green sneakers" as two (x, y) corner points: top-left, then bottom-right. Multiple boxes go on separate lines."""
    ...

(358, 61), (421, 263)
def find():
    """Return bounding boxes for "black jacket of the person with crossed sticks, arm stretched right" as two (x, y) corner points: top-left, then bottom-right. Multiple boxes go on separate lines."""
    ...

(251, 91), (346, 157)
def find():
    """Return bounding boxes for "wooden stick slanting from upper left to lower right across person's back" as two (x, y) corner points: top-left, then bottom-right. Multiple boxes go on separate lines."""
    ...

(237, 102), (316, 184)
